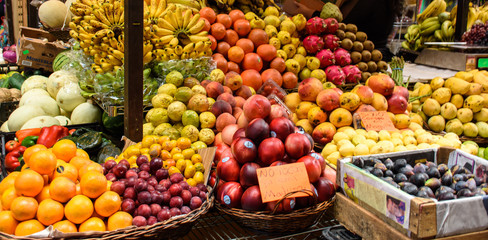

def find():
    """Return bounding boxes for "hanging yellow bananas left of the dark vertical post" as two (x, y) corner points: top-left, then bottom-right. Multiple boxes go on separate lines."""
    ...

(69, 0), (124, 73)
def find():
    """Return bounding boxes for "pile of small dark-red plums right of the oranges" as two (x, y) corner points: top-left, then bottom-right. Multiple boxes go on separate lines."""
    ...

(103, 155), (207, 227)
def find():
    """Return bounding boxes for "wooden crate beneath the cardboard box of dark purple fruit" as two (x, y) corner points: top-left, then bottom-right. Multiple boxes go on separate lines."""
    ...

(333, 193), (488, 240)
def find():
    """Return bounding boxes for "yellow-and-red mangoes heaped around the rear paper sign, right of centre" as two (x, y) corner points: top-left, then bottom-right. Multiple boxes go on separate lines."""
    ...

(285, 74), (422, 145)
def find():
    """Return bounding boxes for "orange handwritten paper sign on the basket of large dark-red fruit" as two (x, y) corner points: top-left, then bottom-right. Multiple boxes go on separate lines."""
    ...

(256, 162), (311, 202)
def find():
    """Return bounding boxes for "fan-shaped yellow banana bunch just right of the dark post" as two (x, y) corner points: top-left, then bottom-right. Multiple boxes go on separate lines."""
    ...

(150, 5), (212, 61)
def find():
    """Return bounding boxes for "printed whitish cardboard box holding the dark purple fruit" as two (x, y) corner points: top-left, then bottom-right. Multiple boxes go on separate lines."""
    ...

(337, 147), (488, 238)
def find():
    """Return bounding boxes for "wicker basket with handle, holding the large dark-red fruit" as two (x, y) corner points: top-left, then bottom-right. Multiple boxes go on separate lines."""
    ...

(215, 190), (335, 232)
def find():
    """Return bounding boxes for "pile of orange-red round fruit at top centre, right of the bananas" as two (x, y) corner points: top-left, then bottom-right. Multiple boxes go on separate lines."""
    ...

(200, 8), (297, 91)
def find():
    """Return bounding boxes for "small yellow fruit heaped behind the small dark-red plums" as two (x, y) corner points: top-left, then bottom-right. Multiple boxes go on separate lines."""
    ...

(112, 135), (207, 186)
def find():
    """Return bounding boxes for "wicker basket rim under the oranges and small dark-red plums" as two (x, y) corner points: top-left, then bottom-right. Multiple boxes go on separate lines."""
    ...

(0, 188), (214, 240)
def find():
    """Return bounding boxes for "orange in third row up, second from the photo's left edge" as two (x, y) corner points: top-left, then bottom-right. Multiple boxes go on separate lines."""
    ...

(14, 169), (43, 197)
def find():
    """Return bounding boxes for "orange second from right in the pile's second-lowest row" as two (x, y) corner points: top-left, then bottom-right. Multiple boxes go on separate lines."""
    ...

(64, 195), (93, 224)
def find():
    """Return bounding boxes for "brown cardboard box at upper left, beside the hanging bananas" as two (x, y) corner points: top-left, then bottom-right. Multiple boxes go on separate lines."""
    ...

(17, 27), (67, 71)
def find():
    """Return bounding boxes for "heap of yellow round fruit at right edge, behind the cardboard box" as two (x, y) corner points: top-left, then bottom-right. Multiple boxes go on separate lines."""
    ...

(412, 70), (488, 139)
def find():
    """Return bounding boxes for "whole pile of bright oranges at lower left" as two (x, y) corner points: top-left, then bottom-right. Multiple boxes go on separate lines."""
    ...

(0, 139), (132, 236)
